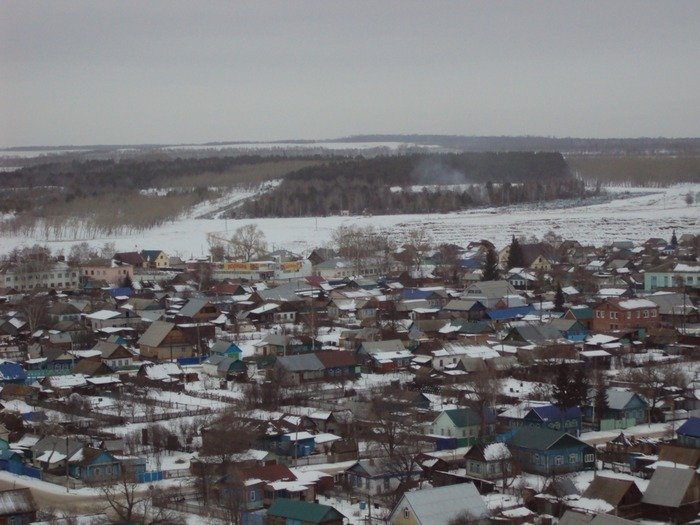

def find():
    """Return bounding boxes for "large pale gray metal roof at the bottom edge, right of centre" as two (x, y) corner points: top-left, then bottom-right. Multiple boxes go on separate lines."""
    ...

(392, 483), (489, 525)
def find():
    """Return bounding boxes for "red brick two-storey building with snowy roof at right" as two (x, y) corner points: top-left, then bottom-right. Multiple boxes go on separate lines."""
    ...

(592, 299), (661, 332)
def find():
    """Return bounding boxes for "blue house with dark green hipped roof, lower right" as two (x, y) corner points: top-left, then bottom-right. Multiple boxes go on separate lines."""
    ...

(507, 427), (596, 476)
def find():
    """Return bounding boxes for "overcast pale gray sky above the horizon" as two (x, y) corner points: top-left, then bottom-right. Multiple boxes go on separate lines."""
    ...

(0, 0), (700, 146)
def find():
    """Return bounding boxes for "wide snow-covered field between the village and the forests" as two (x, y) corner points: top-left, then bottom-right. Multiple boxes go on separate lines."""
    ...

(0, 184), (700, 258)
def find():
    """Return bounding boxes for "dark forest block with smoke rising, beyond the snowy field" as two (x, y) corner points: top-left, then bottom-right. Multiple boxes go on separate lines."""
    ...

(237, 152), (585, 217)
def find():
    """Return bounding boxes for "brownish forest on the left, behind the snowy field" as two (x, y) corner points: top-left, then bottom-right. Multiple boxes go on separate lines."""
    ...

(0, 156), (318, 239)
